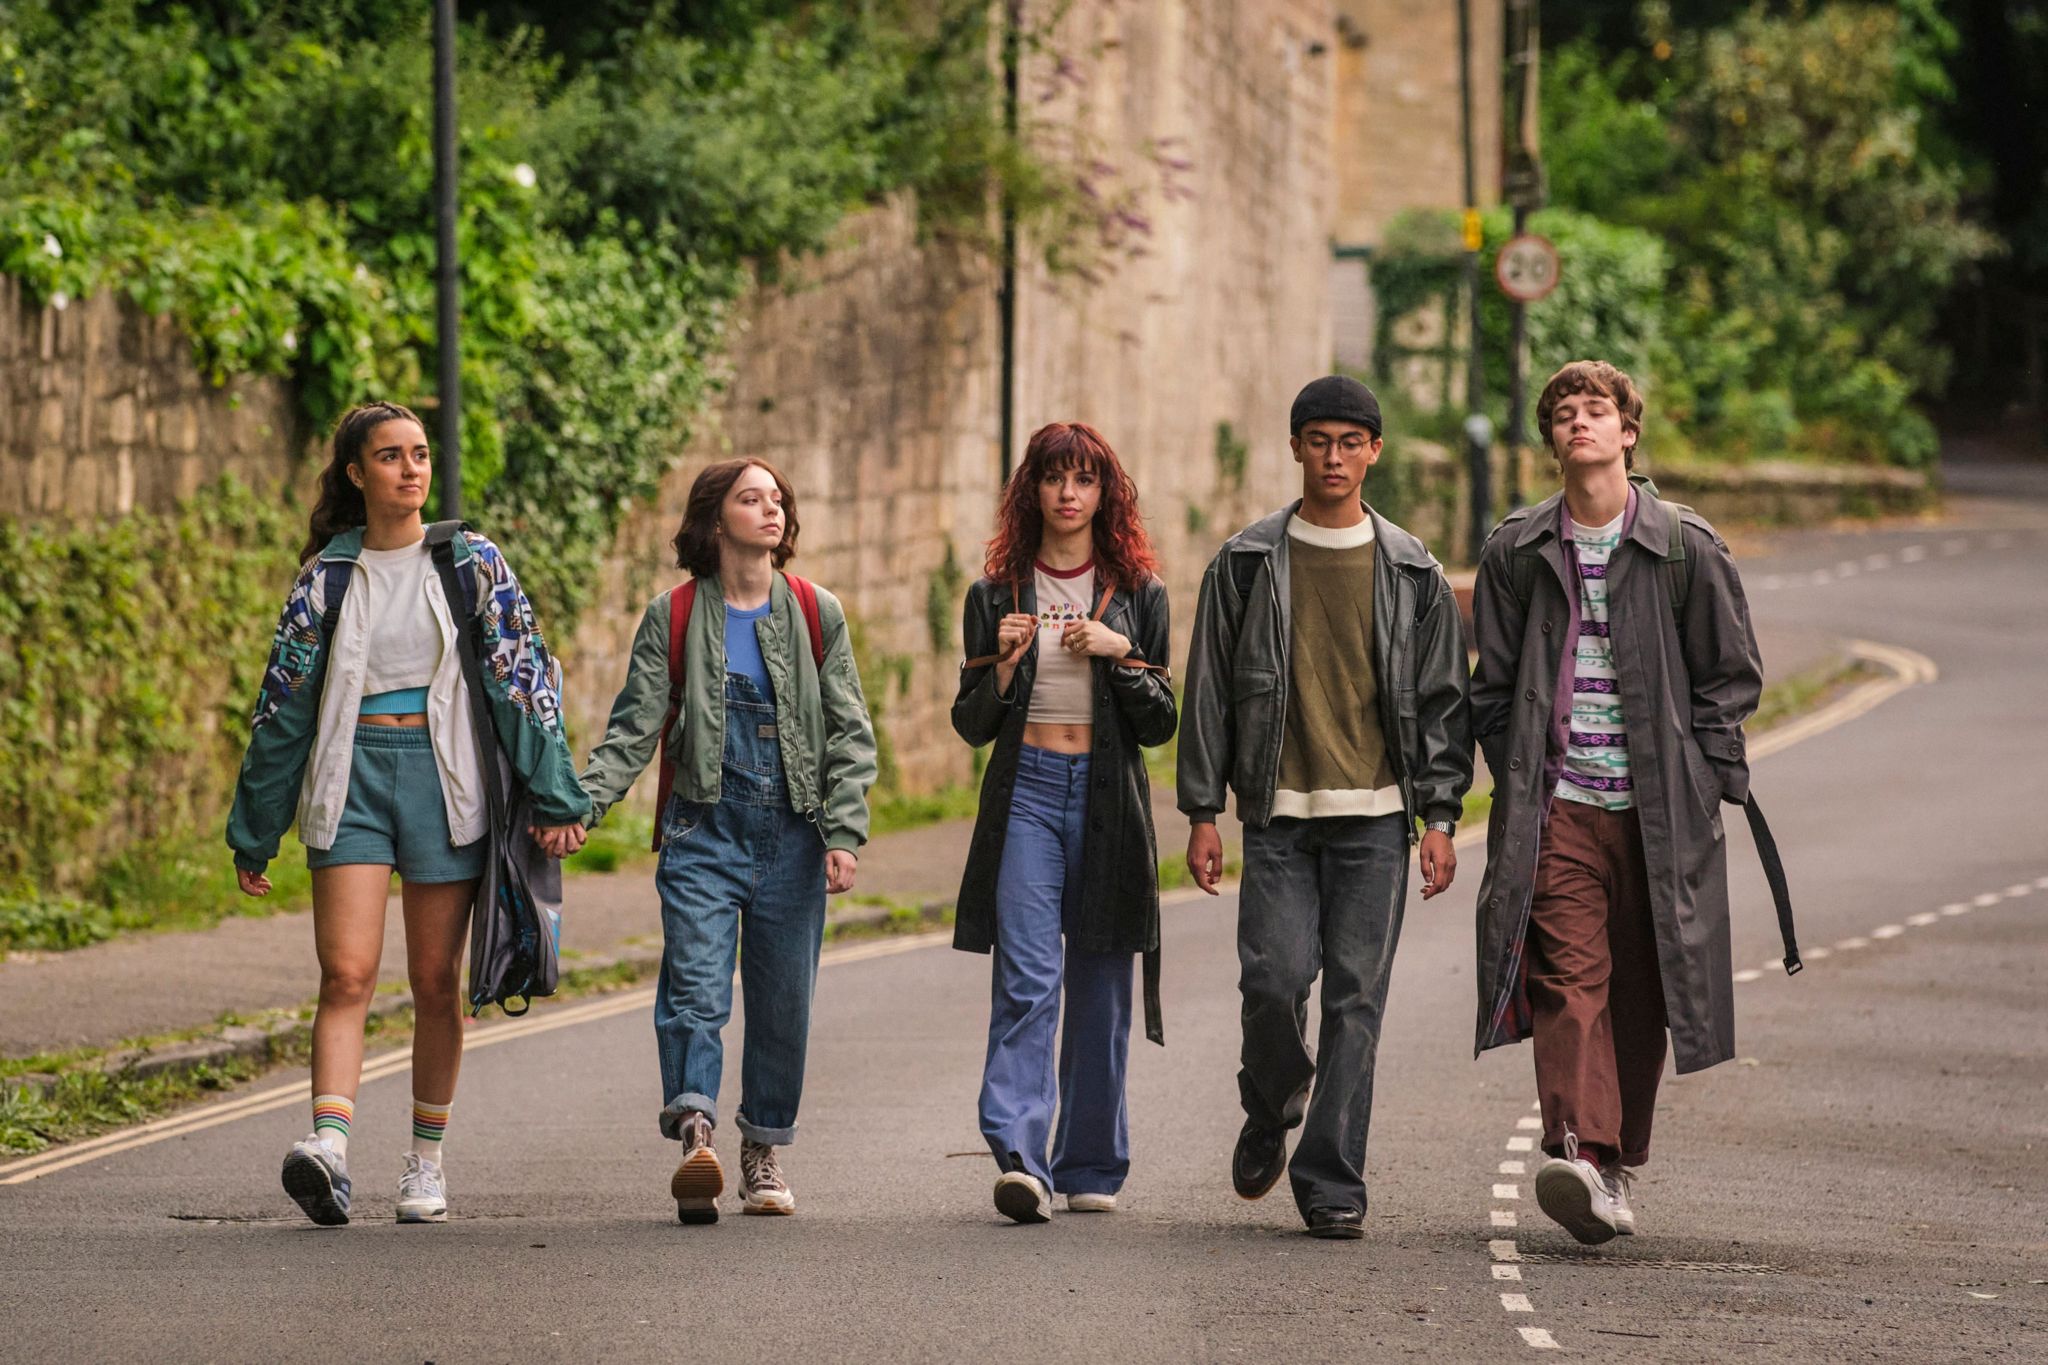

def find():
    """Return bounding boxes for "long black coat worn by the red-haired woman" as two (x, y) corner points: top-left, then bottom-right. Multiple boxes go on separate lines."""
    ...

(952, 579), (1178, 1042)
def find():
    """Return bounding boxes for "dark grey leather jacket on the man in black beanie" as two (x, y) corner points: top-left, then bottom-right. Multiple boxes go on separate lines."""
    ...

(1178, 501), (1473, 839)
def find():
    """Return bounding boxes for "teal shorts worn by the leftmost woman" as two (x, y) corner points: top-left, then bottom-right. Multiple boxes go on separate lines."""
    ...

(305, 724), (489, 882)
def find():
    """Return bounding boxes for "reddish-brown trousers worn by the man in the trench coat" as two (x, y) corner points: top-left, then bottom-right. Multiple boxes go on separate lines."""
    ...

(1528, 800), (1665, 1166)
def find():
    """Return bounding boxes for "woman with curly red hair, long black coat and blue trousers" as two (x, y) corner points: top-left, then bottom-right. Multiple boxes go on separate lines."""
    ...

(952, 422), (1176, 1224)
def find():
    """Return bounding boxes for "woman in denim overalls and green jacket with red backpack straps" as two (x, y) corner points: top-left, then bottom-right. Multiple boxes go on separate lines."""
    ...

(584, 458), (874, 1224)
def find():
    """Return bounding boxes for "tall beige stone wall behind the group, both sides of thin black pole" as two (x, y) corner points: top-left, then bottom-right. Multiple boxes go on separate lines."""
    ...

(563, 0), (1335, 798)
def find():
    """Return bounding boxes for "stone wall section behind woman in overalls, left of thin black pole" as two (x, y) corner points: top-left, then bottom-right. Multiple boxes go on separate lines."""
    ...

(561, 203), (999, 802)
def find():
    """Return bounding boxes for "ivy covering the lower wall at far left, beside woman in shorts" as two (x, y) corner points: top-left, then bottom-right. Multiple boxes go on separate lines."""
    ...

(0, 474), (297, 894)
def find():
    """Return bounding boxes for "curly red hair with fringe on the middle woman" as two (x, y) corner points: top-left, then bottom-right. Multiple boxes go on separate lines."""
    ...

(983, 422), (1159, 589)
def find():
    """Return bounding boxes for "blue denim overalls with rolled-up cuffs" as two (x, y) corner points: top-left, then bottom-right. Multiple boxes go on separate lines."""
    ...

(653, 673), (825, 1144)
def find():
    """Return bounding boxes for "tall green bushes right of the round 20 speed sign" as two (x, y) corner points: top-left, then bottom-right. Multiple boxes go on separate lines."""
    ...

(1544, 0), (1999, 465)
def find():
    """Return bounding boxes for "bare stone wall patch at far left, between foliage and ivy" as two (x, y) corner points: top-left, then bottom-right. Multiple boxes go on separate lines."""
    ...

(0, 276), (295, 520)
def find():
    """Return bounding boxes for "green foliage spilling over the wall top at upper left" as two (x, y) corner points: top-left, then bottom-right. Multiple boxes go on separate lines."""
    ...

(0, 0), (1079, 632)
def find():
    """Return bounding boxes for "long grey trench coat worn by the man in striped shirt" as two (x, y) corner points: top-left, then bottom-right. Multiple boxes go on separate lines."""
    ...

(1473, 491), (1763, 1072)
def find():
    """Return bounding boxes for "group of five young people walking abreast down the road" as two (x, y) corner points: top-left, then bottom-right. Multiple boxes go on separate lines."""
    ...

(227, 362), (1757, 1240)
